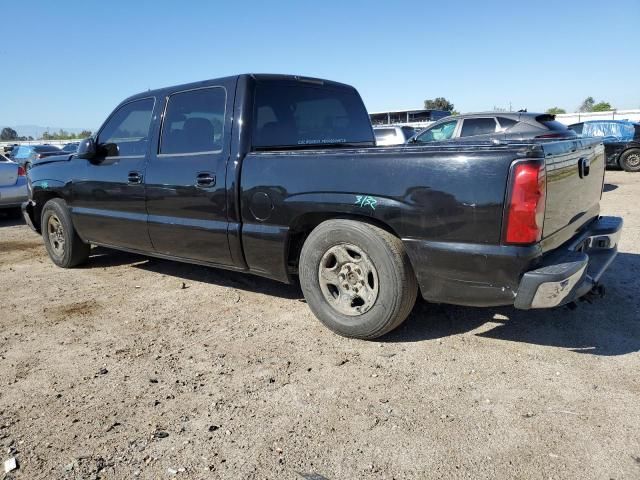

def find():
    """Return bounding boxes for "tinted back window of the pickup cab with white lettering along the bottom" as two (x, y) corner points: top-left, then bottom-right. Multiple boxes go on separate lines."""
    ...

(253, 82), (374, 148)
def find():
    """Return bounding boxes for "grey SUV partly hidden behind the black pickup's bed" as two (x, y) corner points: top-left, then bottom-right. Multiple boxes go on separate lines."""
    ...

(408, 112), (577, 144)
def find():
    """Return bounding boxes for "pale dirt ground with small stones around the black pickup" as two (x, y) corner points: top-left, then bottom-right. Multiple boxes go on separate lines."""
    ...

(0, 171), (640, 480)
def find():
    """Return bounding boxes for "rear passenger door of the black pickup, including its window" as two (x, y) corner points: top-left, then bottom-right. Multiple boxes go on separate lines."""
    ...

(146, 82), (235, 265)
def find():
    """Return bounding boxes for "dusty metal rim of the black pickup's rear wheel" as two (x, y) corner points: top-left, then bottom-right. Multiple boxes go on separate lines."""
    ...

(318, 244), (379, 316)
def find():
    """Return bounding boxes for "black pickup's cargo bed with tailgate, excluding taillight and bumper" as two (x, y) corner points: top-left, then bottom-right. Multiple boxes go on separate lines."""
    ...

(238, 139), (604, 305)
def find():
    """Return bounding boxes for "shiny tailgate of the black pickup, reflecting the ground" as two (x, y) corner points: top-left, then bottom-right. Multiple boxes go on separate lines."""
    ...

(542, 139), (605, 248)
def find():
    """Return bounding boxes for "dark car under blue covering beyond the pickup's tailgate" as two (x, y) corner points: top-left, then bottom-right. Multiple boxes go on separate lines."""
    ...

(569, 120), (640, 172)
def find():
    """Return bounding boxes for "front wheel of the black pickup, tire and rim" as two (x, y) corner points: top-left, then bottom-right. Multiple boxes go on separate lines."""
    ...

(41, 198), (91, 268)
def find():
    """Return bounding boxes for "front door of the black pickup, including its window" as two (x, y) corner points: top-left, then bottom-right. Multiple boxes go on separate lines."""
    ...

(71, 97), (155, 250)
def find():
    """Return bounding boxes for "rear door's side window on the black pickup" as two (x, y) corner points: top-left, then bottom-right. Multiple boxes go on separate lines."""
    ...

(159, 87), (227, 155)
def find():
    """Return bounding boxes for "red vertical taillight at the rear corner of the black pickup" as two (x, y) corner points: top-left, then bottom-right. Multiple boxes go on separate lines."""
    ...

(504, 163), (547, 244)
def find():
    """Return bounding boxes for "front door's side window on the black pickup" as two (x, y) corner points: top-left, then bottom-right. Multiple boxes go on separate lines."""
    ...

(98, 98), (155, 157)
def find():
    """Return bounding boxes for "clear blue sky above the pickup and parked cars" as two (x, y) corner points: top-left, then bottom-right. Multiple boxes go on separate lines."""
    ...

(0, 0), (640, 129)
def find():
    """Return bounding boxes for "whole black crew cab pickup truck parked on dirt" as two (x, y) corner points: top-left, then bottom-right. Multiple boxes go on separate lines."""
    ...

(23, 75), (622, 338)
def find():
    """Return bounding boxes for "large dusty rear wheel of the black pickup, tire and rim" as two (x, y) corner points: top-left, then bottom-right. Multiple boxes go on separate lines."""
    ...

(299, 219), (418, 339)
